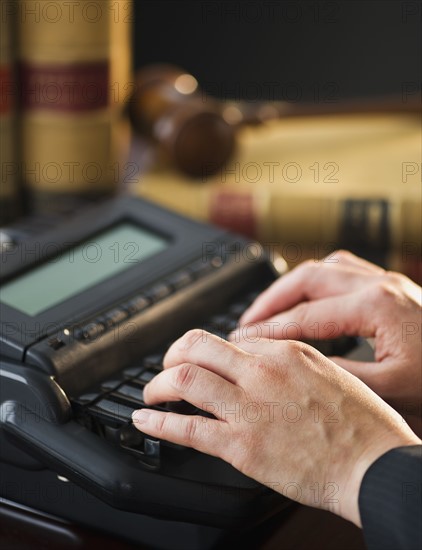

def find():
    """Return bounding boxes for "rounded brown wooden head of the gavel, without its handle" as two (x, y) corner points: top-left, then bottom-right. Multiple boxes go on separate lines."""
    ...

(129, 65), (235, 177)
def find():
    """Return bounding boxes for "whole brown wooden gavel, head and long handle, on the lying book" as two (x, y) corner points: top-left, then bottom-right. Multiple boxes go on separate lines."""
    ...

(128, 64), (420, 177)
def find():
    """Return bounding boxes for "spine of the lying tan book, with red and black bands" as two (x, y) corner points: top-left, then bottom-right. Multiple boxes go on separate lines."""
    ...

(138, 172), (421, 284)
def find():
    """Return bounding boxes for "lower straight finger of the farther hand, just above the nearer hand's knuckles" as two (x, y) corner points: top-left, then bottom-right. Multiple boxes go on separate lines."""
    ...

(234, 289), (375, 344)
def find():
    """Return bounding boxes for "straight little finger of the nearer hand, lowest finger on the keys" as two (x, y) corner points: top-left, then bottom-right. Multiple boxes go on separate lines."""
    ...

(132, 409), (230, 458)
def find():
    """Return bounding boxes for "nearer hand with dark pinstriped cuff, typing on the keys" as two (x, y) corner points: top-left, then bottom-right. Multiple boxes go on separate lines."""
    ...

(133, 330), (420, 525)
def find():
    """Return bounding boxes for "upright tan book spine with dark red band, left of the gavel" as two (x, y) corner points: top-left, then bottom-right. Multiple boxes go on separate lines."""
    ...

(19, 0), (132, 209)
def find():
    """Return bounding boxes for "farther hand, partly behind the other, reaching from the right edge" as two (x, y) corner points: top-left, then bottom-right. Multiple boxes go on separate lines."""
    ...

(234, 251), (422, 422)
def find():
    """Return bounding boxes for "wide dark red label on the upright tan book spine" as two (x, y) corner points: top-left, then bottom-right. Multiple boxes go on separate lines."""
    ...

(21, 61), (109, 112)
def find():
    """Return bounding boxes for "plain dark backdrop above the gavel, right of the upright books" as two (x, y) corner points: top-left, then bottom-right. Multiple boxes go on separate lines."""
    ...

(134, 0), (422, 103)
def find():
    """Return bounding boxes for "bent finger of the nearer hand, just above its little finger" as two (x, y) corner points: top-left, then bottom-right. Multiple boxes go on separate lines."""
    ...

(143, 363), (243, 418)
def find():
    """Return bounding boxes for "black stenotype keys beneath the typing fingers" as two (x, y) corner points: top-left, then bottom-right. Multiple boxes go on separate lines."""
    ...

(71, 288), (263, 469)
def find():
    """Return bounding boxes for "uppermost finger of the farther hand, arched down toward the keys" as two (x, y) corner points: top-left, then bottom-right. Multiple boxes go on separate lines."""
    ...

(239, 261), (380, 325)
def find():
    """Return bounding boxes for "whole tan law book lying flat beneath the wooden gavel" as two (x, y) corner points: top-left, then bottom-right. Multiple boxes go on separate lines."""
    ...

(136, 115), (421, 282)
